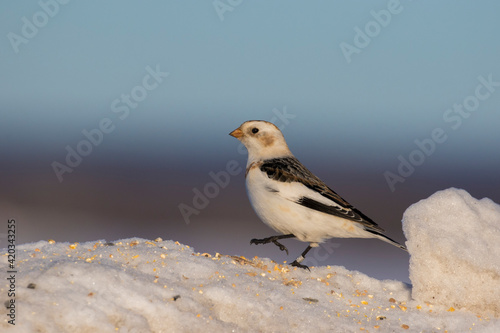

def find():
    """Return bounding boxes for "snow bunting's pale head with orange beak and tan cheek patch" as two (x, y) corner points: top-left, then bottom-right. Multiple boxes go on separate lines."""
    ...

(229, 120), (292, 163)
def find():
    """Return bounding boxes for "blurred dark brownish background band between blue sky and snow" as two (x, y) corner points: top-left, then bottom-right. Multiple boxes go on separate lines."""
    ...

(0, 153), (500, 282)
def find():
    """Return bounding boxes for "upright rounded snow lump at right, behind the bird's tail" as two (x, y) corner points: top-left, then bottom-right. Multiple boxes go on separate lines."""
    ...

(403, 188), (500, 317)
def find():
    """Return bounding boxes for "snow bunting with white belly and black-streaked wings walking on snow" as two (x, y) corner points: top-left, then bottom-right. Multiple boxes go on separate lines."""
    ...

(229, 120), (406, 269)
